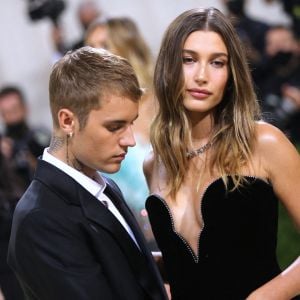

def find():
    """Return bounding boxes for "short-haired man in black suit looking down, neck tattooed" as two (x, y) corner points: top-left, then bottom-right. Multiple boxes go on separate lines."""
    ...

(8, 47), (166, 300)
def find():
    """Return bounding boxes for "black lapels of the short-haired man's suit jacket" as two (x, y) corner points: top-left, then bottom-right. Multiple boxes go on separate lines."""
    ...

(80, 185), (162, 299)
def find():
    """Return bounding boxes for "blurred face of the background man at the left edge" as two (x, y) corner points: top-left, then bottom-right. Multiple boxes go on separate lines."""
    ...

(0, 93), (26, 125)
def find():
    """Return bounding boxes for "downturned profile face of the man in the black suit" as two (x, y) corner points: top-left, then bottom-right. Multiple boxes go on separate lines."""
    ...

(69, 95), (138, 177)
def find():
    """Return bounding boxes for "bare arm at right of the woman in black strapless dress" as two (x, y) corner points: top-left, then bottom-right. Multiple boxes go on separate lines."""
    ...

(247, 124), (300, 300)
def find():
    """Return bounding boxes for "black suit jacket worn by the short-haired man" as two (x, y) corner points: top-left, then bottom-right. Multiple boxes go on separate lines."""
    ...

(8, 160), (167, 300)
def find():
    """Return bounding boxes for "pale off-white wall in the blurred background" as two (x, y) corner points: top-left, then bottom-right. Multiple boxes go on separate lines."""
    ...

(0, 0), (289, 126)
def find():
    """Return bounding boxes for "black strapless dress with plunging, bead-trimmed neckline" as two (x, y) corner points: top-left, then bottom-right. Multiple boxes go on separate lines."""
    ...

(146, 176), (280, 300)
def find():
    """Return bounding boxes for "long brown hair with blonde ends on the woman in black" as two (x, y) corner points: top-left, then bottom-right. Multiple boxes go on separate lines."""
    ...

(151, 8), (260, 198)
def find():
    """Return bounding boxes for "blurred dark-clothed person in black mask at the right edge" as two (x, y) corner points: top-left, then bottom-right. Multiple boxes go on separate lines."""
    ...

(257, 25), (300, 144)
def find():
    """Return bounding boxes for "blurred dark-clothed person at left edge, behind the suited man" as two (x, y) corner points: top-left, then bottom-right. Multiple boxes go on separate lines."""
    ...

(0, 86), (50, 300)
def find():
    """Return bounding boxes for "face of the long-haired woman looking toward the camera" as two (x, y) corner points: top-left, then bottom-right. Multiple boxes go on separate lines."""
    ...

(182, 30), (229, 114)
